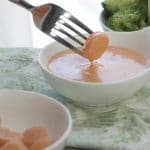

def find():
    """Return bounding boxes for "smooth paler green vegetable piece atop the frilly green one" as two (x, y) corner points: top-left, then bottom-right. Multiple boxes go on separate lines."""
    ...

(102, 0), (148, 13)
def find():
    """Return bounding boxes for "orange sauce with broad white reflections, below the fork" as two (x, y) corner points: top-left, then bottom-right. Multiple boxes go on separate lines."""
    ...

(48, 46), (150, 82)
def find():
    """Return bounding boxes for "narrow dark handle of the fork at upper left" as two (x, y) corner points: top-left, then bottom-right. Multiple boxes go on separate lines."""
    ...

(9, 0), (34, 11)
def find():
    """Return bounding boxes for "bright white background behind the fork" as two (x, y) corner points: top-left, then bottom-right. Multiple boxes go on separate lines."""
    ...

(0, 0), (102, 47)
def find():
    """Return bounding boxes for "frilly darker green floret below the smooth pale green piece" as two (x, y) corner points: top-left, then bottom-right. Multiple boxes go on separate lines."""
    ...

(106, 6), (147, 31)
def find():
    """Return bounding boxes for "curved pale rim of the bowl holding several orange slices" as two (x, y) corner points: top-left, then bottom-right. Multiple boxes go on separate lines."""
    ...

(0, 89), (72, 149)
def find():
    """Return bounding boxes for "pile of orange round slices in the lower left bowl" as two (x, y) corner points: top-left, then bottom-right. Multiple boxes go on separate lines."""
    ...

(0, 127), (52, 150)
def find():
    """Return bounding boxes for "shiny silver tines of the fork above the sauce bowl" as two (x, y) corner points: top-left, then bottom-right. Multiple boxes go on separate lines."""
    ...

(50, 12), (92, 49)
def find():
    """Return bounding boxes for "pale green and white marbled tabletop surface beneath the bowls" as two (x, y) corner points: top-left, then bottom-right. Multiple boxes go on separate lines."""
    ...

(0, 48), (150, 150)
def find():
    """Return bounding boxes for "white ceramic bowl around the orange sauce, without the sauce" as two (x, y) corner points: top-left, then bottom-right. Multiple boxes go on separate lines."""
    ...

(39, 28), (150, 106)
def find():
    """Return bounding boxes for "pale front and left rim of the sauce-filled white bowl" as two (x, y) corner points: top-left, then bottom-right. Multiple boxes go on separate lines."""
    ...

(38, 42), (150, 86)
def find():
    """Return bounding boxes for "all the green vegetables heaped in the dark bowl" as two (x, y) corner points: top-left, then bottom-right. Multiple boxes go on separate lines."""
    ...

(102, 0), (148, 31)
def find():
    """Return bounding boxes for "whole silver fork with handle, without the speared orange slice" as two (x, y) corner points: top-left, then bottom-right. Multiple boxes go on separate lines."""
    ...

(9, 0), (92, 53)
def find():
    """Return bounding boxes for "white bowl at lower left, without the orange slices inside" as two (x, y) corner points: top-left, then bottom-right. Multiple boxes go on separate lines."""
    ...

(0, 90), (72, 150)
